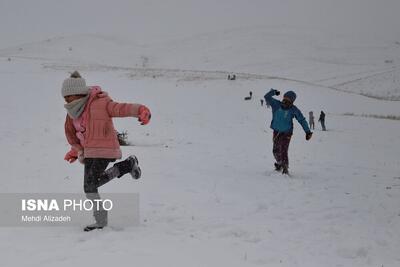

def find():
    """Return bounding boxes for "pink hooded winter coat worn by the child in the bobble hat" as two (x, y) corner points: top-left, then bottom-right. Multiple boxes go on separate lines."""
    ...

(65, 86), (141, 159)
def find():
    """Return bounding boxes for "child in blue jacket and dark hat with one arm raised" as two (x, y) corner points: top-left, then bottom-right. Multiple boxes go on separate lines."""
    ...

(264, 89), (312, 174)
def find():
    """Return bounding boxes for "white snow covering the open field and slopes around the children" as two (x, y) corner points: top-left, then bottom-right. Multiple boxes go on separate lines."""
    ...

(0, 24), (400, 267)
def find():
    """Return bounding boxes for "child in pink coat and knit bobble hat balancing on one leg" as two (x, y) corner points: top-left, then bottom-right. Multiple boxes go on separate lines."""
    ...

(61, 71), (151, 231)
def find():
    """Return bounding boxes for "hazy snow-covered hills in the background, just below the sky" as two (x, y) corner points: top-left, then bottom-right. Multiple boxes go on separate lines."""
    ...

(0, 26), (400, 100)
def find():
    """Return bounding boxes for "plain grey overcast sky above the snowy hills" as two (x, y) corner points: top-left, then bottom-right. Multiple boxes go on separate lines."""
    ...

(0, 0), (400, 47)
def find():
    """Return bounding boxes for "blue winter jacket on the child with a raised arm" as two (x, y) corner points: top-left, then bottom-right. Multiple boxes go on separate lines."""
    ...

(264, 89), (311, 133)
